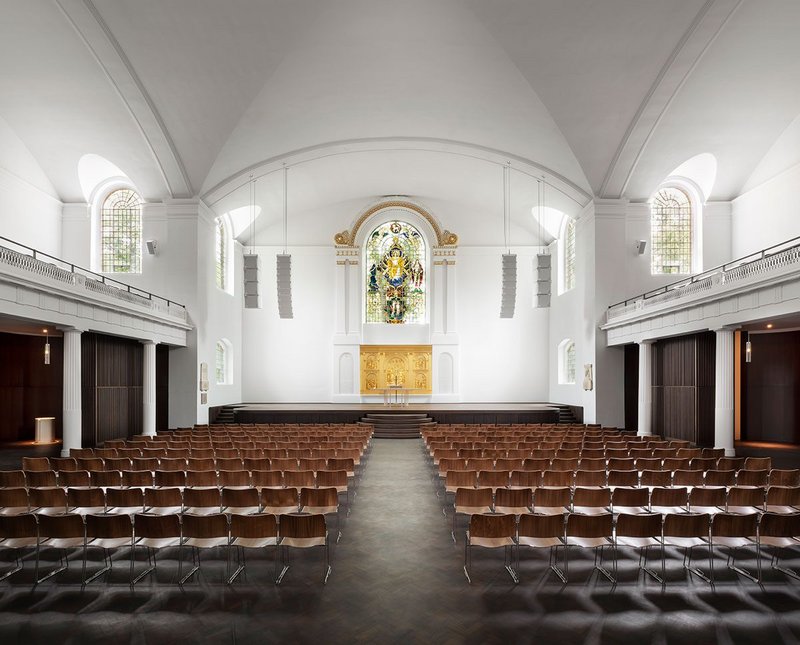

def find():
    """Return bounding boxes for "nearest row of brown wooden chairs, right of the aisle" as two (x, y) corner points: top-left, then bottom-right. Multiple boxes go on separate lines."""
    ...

(464, 512), (800, 585)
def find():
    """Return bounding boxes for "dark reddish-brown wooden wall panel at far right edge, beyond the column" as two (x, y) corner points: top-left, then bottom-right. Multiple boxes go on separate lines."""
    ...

(742, 331), (800, 444)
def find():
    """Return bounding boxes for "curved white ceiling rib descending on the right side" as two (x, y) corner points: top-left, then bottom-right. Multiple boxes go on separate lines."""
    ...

(598, 0), (744, 198)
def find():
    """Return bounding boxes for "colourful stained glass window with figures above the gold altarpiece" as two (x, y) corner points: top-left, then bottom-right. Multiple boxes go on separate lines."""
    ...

(366, 222), (426, 325)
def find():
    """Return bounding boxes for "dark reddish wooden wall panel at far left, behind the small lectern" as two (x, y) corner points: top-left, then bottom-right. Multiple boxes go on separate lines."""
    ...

(0, 333), (64, 441)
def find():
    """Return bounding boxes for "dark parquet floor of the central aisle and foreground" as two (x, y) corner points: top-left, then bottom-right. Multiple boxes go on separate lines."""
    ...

(0, 439), (800, 645)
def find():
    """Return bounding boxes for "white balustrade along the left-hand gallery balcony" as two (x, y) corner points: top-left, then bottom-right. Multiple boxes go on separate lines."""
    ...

(0, 237), (187, 321)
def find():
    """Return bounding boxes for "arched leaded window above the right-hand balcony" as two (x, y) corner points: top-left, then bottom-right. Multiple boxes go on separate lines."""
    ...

(650, 188), (692, 274)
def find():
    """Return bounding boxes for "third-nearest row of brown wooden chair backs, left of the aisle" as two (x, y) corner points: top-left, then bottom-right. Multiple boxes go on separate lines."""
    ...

(0, 460), (356, 491)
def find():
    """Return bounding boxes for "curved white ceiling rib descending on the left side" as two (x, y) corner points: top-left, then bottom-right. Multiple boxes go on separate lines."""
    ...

(55, 0), (194, 198)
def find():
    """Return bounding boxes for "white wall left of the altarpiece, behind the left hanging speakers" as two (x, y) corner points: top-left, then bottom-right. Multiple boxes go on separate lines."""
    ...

(236, 245), (336, 402)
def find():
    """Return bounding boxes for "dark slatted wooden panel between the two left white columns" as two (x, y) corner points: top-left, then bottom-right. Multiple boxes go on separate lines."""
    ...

(81, 333), (144, 447)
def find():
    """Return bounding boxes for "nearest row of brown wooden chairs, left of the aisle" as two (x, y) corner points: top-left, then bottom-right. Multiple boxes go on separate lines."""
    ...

(0, 513), (331, 588)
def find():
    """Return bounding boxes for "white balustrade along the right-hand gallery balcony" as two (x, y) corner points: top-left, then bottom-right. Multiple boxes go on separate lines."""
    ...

(606, 238), (800, 322)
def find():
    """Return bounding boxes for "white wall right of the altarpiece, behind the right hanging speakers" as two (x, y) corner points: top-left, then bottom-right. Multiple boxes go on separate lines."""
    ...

(455, 247), (549, 402)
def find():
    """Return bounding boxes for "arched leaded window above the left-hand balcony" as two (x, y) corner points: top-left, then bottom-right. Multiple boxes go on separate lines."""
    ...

(100, 188), (142, 273)
